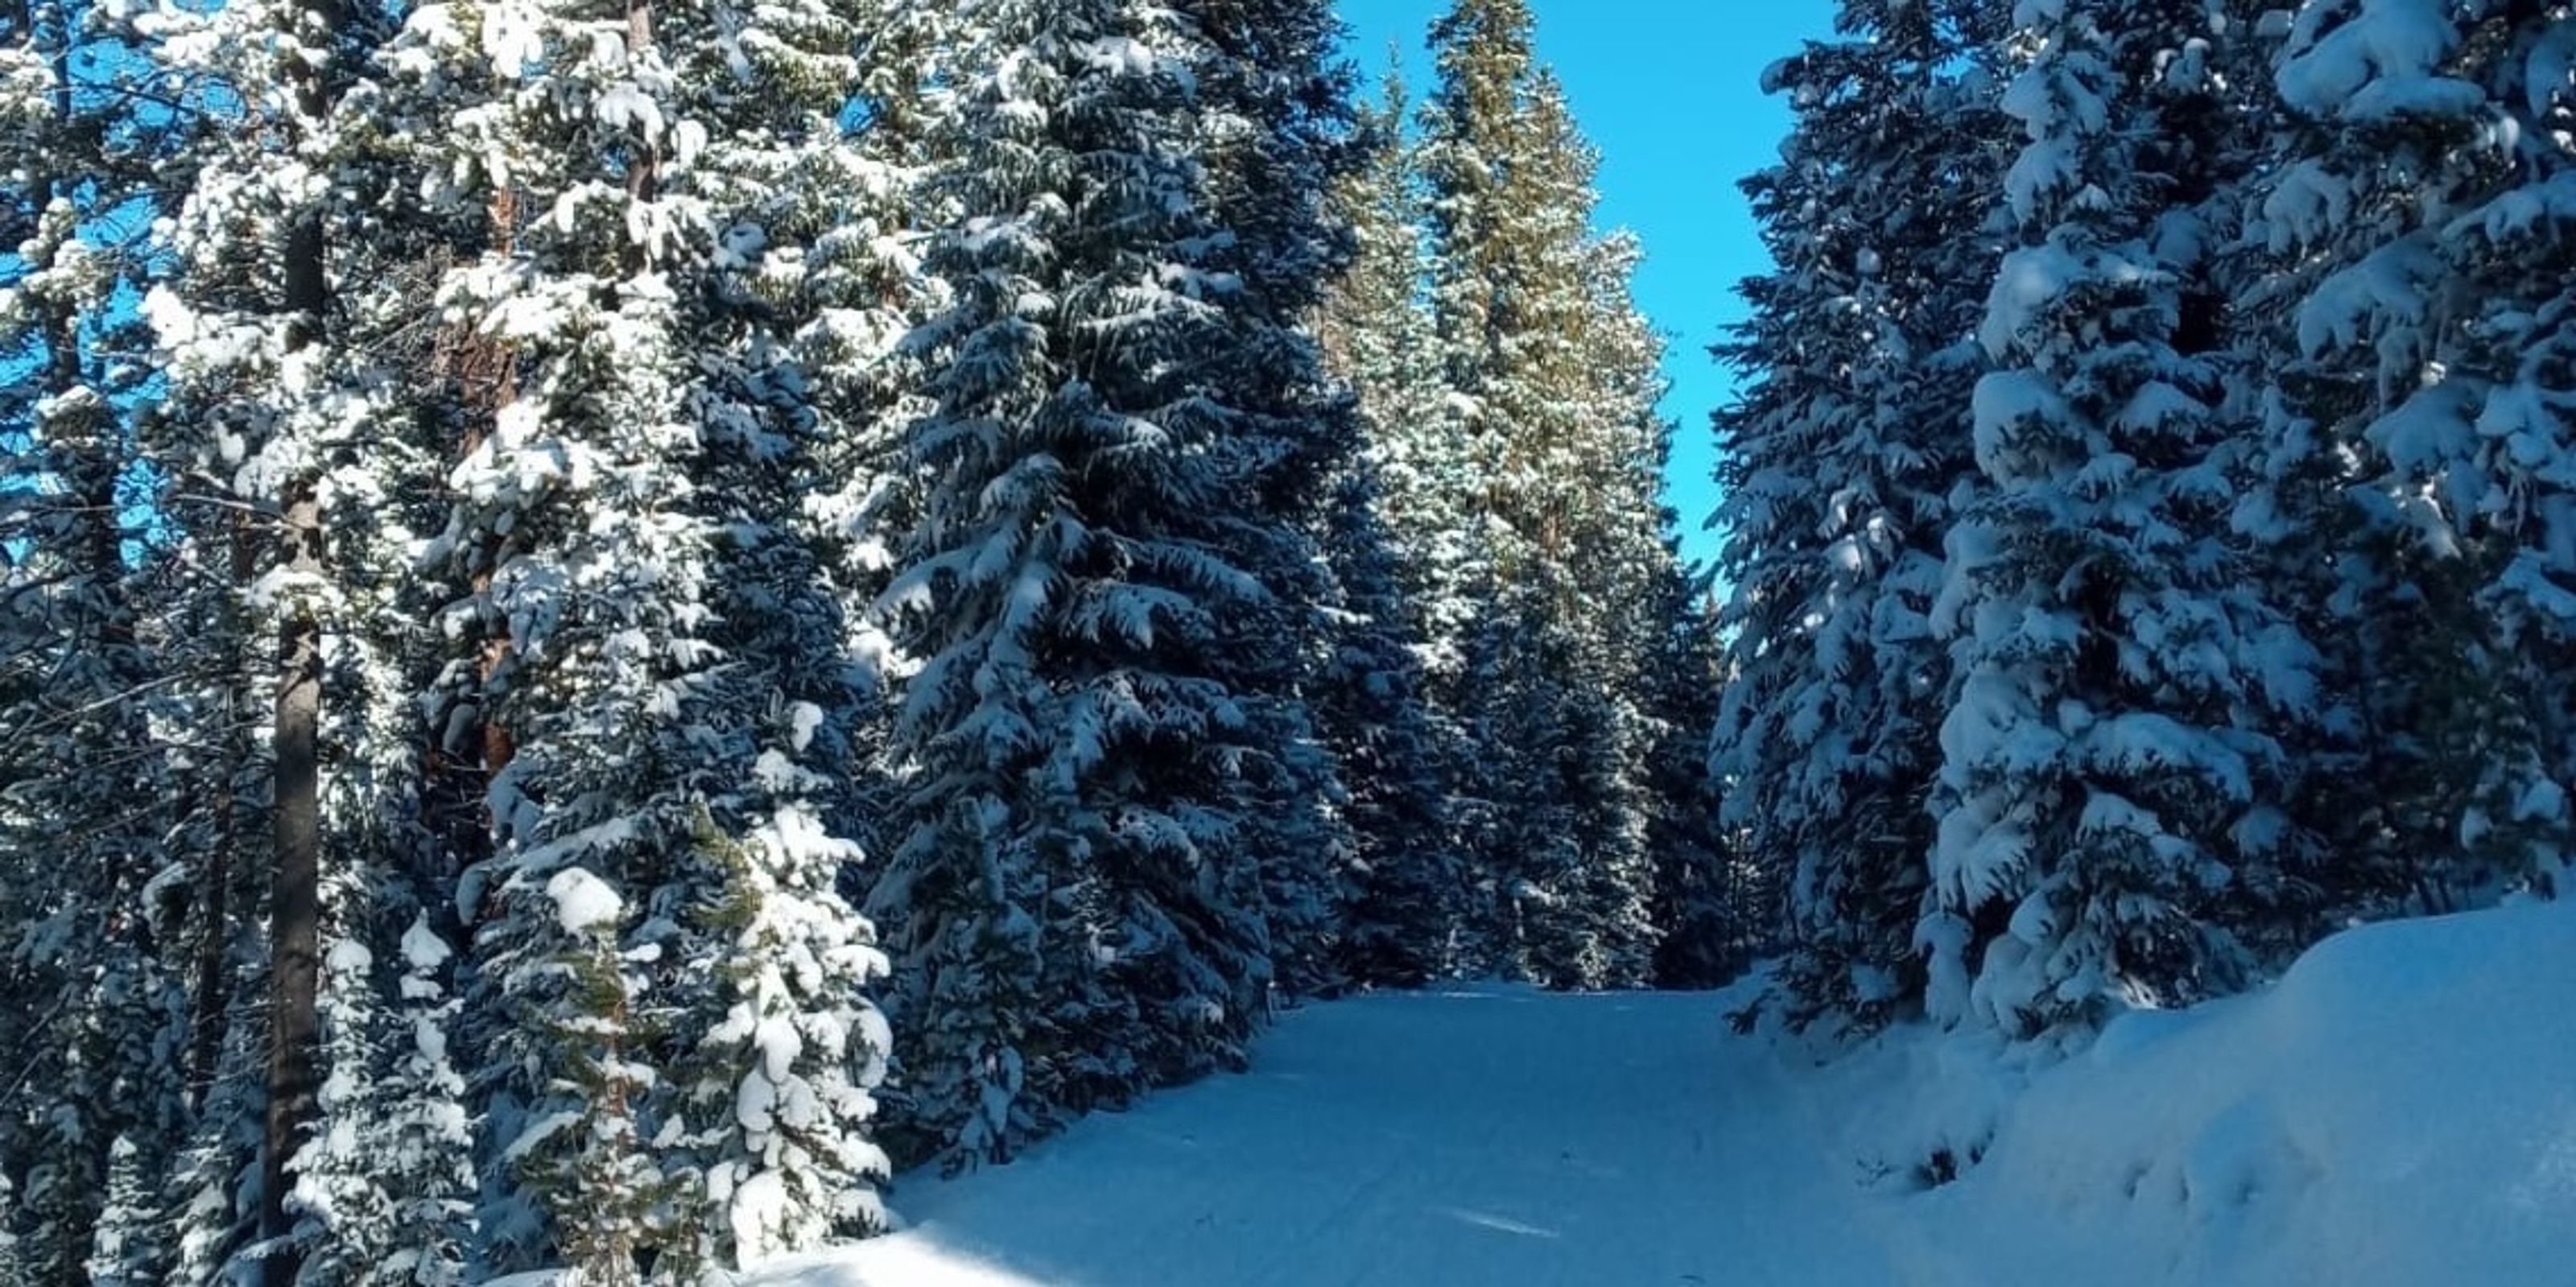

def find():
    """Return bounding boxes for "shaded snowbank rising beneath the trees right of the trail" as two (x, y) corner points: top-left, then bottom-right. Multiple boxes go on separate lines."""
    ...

(1814, 903), (2576, 1287)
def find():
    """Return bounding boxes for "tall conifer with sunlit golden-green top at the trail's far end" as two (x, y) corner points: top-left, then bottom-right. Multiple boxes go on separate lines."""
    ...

(1422, 0), (1670, 986)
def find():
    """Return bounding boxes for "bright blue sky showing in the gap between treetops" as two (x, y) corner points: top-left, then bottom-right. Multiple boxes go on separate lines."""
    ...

(1340, 0), (1834, 559)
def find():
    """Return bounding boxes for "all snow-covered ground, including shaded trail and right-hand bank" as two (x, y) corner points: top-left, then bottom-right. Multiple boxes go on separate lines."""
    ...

(758, 906), (2576, 1287)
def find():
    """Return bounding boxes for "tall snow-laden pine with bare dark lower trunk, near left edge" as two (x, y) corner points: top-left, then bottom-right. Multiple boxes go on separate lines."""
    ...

(144, 0), (427, 1266)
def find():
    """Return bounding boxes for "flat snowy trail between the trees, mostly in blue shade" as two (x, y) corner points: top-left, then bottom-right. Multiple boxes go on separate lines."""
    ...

(760, 988), (1896, 1287)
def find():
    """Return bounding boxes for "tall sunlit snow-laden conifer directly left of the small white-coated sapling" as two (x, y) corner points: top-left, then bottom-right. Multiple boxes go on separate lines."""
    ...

(404, 0), (742, 1261)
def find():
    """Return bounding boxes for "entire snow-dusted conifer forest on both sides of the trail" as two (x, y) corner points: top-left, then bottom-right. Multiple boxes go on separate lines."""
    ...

(0, 0), (2576, 1287)
